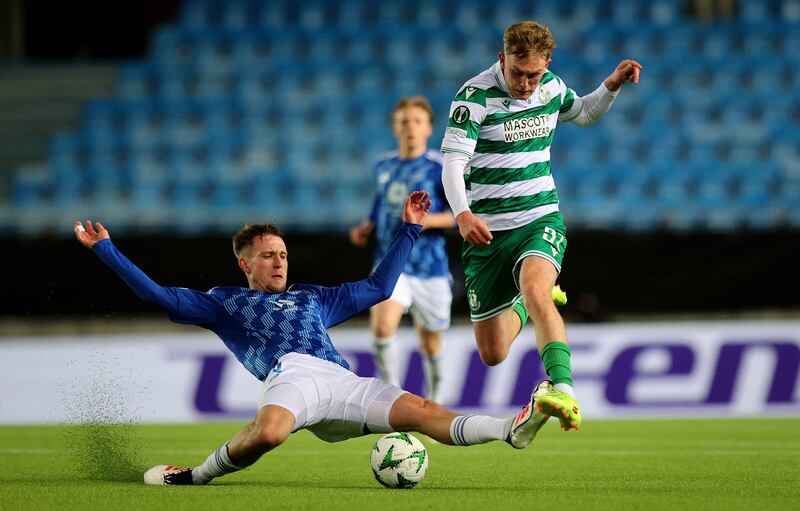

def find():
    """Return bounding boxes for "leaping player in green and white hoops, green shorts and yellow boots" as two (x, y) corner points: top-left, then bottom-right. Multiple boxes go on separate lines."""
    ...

(442, 21), (642, 430)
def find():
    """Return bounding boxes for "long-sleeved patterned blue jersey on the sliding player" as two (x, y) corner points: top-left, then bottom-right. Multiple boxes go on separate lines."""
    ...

(93, 224), (422, 380)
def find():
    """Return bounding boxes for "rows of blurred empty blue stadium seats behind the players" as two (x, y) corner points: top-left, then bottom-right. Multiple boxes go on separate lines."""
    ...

(11, 0), (800, 233)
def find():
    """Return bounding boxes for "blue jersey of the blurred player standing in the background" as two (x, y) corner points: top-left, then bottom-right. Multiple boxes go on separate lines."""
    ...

(369, 150), (450, 278)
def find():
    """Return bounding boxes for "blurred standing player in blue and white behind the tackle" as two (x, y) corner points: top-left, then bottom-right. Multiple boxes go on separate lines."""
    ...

(350, 96), (456, 402)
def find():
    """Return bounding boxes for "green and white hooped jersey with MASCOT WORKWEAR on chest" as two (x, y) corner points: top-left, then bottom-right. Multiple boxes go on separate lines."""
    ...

(442, 61), (582, 231)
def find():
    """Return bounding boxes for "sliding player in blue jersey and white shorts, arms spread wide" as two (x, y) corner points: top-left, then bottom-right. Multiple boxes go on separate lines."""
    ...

(73, 191), (549, 485)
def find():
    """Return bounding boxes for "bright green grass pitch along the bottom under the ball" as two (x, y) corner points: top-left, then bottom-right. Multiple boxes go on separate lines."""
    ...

(0, 419), (800, 511)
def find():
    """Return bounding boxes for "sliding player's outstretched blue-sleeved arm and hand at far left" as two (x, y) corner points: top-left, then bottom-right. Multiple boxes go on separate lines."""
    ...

(73, 220), (224, 325)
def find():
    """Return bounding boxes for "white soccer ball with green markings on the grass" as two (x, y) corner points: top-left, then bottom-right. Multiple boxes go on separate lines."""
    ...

(370, 433), (428, 488)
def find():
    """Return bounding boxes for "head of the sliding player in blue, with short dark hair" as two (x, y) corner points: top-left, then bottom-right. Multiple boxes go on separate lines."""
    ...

(240, 234), (289, 293)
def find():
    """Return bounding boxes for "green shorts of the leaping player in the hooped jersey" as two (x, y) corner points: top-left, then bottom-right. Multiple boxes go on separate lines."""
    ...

(461, 211), (567, 321)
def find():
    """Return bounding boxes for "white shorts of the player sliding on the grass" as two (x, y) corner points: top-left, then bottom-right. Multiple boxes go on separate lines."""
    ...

(258, 353), (406, 442)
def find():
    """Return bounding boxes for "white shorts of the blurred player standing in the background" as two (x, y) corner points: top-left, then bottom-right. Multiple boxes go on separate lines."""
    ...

(389, 273), (453, 332)
